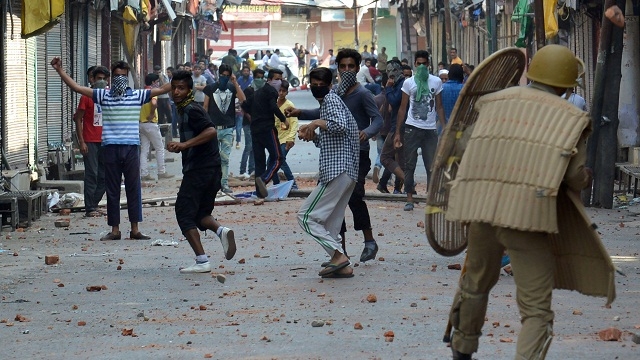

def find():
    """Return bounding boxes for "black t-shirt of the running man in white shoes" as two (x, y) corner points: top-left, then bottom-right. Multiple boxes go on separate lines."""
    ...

(178, 102), (221, 173)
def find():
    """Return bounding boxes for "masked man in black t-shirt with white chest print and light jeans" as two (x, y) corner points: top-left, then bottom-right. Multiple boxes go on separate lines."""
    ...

(203, 64), (245, 193)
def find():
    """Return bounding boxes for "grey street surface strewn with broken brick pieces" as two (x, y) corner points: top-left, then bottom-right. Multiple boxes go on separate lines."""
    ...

(0, 92), (640, 360)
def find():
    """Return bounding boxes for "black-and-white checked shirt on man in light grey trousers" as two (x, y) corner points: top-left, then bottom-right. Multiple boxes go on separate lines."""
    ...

(313, 90), (360, 185)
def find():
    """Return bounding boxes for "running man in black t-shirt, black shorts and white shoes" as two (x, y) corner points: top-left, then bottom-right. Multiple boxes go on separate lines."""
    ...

(167, 71), (236, 274)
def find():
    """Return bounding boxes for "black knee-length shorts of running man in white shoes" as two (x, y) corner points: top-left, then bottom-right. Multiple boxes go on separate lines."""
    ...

(176, 167), (222, 233)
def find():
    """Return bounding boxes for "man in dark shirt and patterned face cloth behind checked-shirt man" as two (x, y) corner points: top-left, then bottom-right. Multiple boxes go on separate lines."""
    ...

(287, 49), (382, 265)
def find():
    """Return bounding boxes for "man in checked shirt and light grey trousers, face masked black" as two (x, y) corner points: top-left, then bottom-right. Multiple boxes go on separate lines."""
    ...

(297, 68), (359, 278)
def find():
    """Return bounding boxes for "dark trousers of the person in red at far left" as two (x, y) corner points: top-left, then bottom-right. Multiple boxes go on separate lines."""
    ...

(82, 143), (105, 212)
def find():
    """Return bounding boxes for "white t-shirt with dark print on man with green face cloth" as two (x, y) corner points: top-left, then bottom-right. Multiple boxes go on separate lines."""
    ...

(402, 74), (442, 130)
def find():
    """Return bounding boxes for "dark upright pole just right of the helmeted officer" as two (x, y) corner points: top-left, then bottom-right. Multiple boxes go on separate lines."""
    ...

(583, 0), (626, 209)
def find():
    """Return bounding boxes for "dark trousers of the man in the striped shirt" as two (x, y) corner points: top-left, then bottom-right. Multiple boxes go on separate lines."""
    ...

(104, 145), (142, 226)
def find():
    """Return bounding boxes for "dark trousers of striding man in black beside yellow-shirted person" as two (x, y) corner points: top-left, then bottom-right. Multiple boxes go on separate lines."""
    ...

(251, 127), (282, 190)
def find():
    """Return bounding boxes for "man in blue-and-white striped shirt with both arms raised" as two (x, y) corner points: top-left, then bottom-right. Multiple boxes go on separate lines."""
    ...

(51, 57), (171, 240)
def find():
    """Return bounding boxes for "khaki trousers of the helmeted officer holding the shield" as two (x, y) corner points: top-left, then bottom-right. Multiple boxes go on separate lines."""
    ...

(449, 222), (555, 360)
